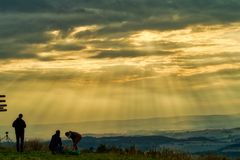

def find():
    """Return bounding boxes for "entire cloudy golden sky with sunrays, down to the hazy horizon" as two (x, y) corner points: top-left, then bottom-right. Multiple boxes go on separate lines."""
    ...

(0, 0), (240, 124)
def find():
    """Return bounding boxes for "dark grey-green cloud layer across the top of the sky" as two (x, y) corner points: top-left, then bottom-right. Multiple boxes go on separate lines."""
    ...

(0, 0), (240, 58)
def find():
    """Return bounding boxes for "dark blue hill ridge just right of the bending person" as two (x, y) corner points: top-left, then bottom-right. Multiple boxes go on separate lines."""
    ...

(76, 136), (217, 150)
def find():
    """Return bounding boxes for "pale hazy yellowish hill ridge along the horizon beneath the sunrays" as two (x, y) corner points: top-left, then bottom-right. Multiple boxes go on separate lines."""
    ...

(0, 114), (240, 139)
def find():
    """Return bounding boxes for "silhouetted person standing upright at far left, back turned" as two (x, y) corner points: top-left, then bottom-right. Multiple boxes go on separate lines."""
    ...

(12, 114), (26, 152)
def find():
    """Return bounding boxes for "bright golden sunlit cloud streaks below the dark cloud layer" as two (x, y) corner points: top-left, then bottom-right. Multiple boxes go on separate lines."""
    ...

(1, 24), (240, 79)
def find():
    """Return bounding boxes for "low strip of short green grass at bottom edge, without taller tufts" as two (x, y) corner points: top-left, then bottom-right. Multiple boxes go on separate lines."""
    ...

(0, 149), (234, 160)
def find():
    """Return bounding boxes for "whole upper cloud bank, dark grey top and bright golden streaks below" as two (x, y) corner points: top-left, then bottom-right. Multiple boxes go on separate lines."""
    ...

(0, 0), (240, 82)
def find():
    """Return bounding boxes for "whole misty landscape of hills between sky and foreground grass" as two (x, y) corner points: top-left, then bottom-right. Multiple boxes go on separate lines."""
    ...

(1, 114), (240, 157)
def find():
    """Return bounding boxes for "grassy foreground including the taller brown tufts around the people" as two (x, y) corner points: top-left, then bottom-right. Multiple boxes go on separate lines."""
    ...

(0, 140), (232, 160)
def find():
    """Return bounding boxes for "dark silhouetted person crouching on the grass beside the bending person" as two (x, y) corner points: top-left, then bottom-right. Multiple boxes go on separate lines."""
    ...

(49, 130), (63, 154)
